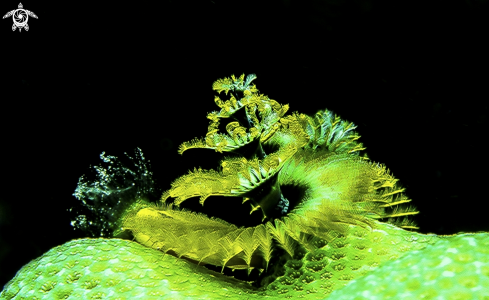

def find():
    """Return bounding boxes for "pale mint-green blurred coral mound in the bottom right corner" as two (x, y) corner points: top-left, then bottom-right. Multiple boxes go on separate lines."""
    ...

(331, 233), (489, 300)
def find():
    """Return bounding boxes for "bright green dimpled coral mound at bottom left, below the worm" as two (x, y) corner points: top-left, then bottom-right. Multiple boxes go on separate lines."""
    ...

(0, 238), (264, 300)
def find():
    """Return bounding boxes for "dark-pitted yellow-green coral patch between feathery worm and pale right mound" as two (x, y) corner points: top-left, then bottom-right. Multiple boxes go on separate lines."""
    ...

(254, 223), (438, 299)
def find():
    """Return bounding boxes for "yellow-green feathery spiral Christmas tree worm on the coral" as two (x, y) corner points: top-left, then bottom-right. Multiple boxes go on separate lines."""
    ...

(119, 74), (417, 272)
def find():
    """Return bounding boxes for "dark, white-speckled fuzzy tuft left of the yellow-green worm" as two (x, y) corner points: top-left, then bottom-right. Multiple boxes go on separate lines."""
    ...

(70, 148), (160, 237)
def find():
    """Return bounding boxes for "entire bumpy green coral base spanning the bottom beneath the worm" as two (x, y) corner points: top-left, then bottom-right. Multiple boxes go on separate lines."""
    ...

(0, 229), (489, 300)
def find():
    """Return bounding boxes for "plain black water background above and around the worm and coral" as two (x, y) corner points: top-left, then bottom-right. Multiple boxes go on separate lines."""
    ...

(0, 0), (489, 286)
